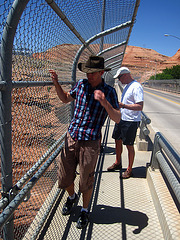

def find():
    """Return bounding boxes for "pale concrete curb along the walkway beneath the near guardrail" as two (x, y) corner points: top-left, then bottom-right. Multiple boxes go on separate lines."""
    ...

(147, 167), (180, 240)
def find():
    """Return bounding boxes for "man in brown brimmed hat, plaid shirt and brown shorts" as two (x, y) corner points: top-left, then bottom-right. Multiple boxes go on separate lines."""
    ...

(49, 56), (121, 229)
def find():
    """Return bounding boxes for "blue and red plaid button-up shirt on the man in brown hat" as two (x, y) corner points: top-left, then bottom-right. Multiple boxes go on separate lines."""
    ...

(68, 79), (119, 141)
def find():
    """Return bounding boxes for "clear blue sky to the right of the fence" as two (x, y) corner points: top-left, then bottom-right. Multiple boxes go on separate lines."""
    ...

(128, 0), (180, 57)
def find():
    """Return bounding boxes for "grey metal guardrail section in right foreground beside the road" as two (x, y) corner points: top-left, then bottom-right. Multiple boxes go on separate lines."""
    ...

(150, 132), (180, 204)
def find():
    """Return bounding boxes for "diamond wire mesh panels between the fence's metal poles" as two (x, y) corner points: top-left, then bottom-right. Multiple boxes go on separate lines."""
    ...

(0, 0), (139, 239)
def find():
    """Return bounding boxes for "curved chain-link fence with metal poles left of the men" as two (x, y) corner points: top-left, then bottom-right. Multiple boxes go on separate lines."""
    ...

(0, 0), (139, 240)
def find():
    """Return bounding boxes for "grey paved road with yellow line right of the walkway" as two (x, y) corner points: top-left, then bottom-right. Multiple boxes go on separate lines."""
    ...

(143, 87), (180, 153)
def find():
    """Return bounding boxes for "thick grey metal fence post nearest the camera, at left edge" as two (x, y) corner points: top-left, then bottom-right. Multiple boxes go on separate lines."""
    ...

(0, 0), (29, 240)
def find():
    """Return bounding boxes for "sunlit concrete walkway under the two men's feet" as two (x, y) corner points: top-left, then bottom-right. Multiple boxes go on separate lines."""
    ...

(40, 121), (164, 240)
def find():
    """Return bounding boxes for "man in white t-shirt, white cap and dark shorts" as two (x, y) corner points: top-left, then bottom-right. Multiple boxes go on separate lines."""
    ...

(107, 67), (144, 179)
